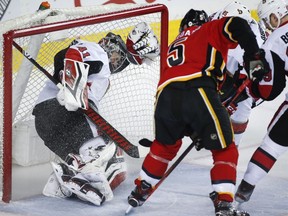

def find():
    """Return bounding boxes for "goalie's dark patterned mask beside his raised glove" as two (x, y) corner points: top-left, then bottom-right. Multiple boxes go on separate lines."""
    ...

(99, 32), (129, 74)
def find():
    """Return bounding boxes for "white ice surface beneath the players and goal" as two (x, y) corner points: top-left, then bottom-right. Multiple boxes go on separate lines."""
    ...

(0, 159), (288, 216)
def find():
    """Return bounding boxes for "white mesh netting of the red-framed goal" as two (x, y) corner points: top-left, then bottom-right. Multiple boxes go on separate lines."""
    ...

(0, 5), (168, 202)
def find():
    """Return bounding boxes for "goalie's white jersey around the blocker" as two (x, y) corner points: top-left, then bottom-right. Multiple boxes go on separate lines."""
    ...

(36, 40), (111, 107)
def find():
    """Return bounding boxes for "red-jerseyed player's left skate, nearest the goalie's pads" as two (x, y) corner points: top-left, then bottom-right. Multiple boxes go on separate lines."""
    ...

(128, 179), (153, 207)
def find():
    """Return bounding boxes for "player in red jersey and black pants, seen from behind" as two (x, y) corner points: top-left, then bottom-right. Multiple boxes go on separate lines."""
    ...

(128, 9), (267, 216)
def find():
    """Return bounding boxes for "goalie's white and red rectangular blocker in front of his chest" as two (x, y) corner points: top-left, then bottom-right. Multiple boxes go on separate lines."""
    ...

(57, 59), (90, 111)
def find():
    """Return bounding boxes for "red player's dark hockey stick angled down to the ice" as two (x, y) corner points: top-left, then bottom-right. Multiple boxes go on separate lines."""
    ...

(125, 136), (195, 214)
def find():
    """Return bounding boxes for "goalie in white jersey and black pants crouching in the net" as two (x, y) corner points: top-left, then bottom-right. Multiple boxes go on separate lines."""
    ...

(33, 22), (159, 206)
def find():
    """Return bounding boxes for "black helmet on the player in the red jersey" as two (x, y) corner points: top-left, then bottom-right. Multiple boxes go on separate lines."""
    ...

(179, 9), (208, 32)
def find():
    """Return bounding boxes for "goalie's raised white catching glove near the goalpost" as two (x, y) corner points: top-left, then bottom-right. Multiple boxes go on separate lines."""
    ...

(126, 22), (160, 65)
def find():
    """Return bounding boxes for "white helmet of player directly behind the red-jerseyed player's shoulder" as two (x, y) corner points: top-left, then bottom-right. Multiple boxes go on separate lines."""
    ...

(219, 1), (253, 24)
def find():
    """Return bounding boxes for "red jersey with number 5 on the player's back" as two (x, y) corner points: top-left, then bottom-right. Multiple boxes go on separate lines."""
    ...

(158, 17), (238, 91)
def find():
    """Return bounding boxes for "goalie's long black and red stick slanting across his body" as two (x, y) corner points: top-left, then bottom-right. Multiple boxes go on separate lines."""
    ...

(13, 41), (140, 158)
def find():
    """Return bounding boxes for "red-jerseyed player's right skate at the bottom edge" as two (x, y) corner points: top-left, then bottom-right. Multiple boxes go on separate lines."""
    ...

(209, 191), (250, 216)
